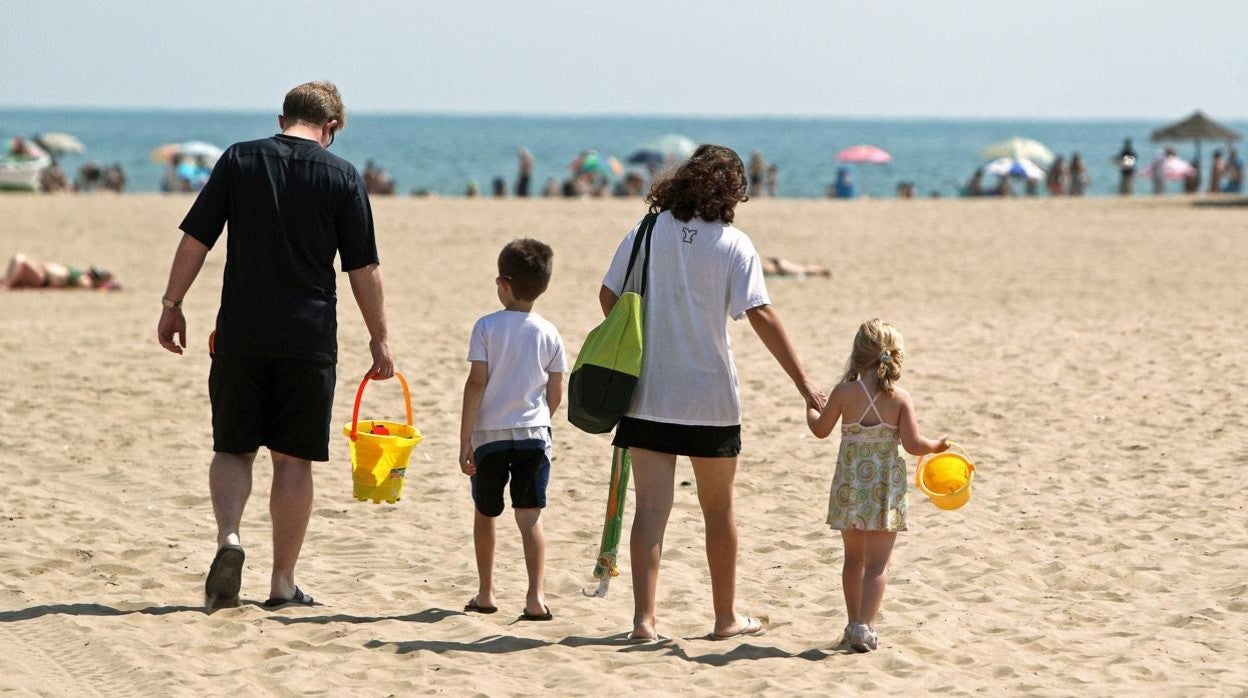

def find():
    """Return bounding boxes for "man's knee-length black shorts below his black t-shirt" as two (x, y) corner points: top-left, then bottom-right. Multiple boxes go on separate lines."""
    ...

(208, 355), (337, 461)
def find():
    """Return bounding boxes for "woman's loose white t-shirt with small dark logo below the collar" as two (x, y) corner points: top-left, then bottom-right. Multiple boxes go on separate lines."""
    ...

(603, 211), (771, 427)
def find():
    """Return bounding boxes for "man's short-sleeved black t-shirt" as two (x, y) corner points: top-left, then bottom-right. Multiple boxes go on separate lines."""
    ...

(181, 134), (377, 363)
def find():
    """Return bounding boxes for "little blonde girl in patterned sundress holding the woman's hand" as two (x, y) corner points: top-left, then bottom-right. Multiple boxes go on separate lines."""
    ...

(806, 320), (948, 652)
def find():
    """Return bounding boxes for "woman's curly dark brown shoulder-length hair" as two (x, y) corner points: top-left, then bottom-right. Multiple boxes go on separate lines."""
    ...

(645, 145), (749, 224)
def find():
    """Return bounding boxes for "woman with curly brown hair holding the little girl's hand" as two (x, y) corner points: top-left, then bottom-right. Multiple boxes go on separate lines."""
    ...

(599, 145), (824, 641)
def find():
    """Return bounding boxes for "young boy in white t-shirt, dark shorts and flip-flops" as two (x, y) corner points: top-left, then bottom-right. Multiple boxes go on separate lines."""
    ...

(459, 238), (568, 621)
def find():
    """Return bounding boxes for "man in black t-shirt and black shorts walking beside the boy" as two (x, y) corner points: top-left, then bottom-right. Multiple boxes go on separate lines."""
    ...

(157, 81), (394, 607)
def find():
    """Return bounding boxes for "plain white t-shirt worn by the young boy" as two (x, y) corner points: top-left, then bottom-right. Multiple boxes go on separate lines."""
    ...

(468, 310), (568, 431)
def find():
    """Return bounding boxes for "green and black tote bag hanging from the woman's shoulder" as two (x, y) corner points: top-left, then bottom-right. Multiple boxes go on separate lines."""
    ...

(568, 214), (659, 433)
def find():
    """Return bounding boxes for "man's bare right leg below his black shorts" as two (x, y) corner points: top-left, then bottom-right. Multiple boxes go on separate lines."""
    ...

(268, 451), (312, 598)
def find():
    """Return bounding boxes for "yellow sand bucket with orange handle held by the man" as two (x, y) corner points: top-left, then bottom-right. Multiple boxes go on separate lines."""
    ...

(342, 371), (423, 504)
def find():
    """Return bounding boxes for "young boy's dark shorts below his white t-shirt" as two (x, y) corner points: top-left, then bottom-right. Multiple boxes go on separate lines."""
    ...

(472, 440), (550, 517)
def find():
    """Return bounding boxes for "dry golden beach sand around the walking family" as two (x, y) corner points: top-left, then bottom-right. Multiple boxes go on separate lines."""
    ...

(0, 196), (1248, 696)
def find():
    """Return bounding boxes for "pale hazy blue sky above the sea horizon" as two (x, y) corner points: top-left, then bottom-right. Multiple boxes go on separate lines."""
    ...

(0, 0), (1248, 120)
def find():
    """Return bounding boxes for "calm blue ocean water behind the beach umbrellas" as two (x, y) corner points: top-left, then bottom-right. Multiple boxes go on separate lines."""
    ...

(0, 109), (1248, 197)
